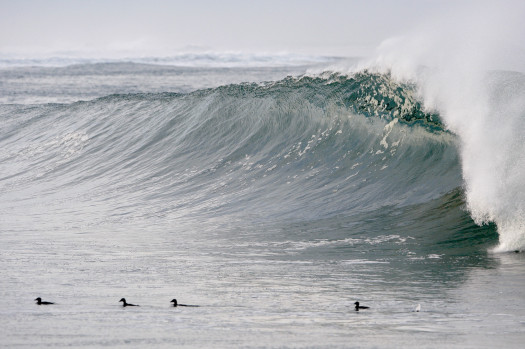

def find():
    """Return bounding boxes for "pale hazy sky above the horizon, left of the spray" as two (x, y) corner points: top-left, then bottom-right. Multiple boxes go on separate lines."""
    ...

(0, 0), (512, 56)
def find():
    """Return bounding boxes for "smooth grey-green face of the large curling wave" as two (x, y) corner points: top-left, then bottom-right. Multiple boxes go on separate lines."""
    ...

(0, 71), (497, 253)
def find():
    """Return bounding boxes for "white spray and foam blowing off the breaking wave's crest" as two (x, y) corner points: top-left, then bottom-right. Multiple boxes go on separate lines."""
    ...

(358, 3), (525, 251)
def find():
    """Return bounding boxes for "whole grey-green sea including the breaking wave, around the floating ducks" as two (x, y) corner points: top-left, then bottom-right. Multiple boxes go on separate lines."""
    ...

(0, 57), (525, 348)
